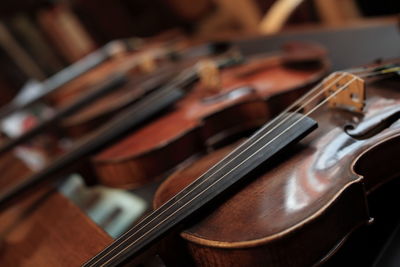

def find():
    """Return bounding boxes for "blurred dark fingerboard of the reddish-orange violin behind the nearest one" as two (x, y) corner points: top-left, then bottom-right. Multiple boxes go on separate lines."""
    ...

(0, 48), (200, 211)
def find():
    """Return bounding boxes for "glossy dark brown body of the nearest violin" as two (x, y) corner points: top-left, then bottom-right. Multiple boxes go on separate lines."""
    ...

(154, 74), (400, 266)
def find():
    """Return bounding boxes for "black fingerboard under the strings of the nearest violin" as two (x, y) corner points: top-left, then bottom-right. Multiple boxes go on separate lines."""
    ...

(85, 113), (317, 266)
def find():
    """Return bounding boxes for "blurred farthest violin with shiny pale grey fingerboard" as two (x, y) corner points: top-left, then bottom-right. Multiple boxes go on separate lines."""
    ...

(0, 31), (209, 119)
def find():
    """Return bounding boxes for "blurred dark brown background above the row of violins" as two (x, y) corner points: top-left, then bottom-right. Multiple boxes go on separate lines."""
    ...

(0, 0), (400, 105)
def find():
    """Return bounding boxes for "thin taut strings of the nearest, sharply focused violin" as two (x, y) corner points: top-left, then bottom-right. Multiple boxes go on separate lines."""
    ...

(87, 66), (396, 264)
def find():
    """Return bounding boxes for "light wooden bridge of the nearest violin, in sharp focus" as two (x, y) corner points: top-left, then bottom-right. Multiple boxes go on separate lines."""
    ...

(323, 72), (365, 112)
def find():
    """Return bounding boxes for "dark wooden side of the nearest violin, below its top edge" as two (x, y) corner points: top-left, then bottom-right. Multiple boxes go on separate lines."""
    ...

(183, 182), (368, 267)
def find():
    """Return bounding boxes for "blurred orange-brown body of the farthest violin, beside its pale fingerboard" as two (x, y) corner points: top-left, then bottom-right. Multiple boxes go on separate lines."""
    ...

(46, 38), (223, 107)
